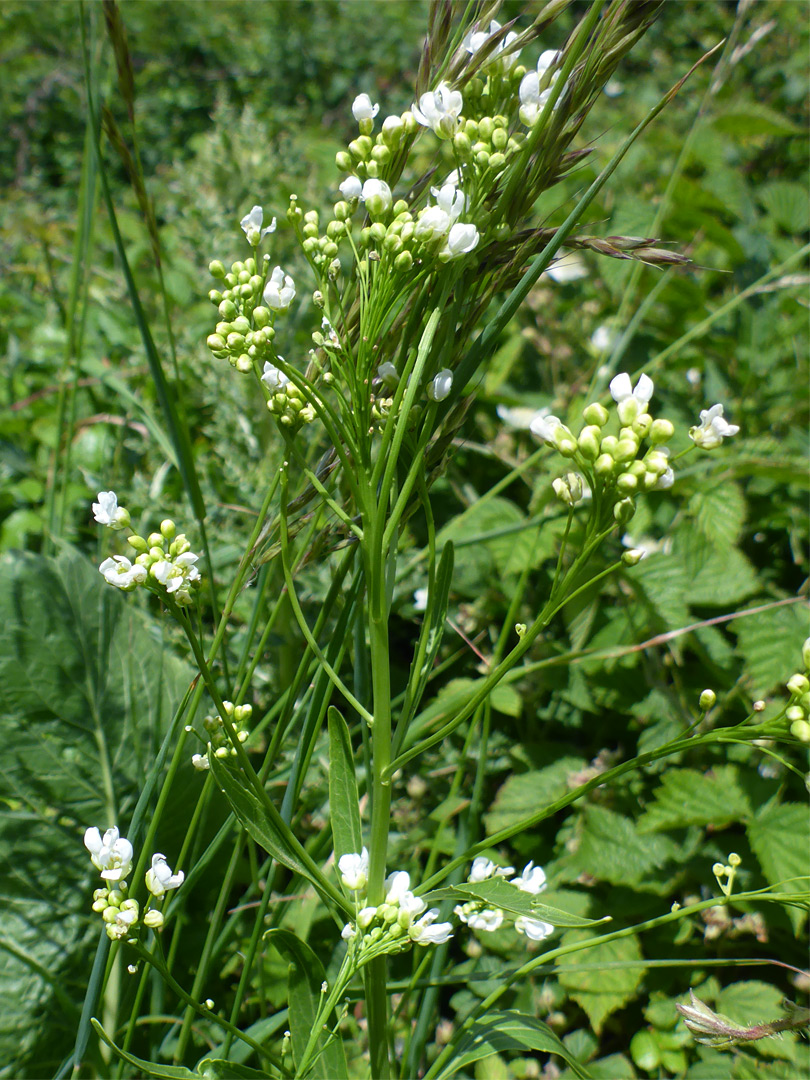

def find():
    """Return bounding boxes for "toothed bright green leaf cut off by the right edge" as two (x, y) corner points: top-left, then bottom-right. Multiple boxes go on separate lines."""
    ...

(746, 802), (810, 933)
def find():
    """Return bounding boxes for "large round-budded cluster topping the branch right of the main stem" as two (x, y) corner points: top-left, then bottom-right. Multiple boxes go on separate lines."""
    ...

(531, 373), (675, 524)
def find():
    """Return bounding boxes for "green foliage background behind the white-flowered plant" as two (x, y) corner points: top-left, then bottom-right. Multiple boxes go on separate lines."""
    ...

(0, 0), (810, 1080)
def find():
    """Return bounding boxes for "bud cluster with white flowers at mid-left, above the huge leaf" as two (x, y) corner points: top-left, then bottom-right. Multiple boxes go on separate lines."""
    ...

(93, 491), (201, 606)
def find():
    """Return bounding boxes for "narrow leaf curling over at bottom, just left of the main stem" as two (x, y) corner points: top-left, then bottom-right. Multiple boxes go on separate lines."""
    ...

(265, 930), (348, 1080)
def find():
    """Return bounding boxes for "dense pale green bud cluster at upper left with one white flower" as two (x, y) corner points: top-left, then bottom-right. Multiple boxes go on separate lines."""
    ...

(206, 245), (295, 375)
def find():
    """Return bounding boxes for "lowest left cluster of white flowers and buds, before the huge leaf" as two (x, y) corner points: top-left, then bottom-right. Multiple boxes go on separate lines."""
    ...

(84, 826), (185, 941)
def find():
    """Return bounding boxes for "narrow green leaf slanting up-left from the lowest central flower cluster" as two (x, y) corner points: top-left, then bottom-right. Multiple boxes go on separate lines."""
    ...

(210, 754), (354, 915)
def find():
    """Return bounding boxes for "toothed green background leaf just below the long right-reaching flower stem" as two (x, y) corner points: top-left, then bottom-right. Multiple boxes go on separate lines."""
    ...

(636, 765), (752, 833)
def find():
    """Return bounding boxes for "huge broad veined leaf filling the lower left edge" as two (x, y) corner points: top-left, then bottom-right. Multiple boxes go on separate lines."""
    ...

(0, 548), (191, 1077)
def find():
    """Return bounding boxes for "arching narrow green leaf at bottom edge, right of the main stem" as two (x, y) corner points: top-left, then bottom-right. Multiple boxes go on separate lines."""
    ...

(436, 1011), (590, 1080)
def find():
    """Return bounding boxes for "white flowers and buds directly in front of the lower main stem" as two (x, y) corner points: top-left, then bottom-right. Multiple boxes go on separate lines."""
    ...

(338, 848), (453, 957)
